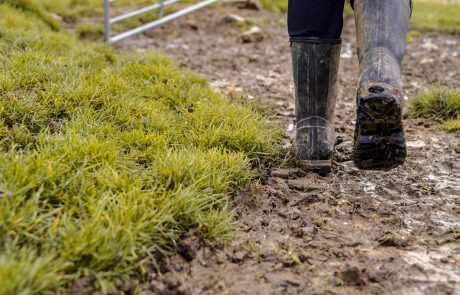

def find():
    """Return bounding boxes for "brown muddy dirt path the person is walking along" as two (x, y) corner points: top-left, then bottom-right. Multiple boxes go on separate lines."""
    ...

(120, 7), (460, 294)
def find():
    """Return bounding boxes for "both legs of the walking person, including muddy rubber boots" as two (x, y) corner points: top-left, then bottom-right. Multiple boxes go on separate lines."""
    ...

(288, 0), (411, 172)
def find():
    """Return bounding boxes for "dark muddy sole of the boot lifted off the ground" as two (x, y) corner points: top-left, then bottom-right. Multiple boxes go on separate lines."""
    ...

(354, 86), (407, 170)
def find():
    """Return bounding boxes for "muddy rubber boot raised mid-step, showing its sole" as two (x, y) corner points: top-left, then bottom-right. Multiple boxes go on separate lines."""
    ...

(354, 0), (411, 169)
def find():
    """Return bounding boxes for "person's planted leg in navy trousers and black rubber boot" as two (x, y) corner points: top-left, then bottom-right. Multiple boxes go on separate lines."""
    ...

(288, 0), (344, 173)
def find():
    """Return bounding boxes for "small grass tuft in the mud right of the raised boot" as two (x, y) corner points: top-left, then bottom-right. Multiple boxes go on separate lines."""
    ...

(408, 86), (460, 131)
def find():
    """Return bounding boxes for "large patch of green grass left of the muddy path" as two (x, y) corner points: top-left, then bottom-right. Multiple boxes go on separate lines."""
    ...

(0, 0), (282, 295)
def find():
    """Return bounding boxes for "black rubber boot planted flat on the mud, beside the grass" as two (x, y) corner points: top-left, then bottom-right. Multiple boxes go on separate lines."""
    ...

(291, 37), (340, 174)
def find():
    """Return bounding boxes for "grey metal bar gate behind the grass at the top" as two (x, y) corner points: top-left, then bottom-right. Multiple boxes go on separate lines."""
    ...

(104, 0), (218, 43)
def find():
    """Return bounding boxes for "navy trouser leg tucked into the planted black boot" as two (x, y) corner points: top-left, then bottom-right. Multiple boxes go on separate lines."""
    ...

(288, 0), (353, 39)
